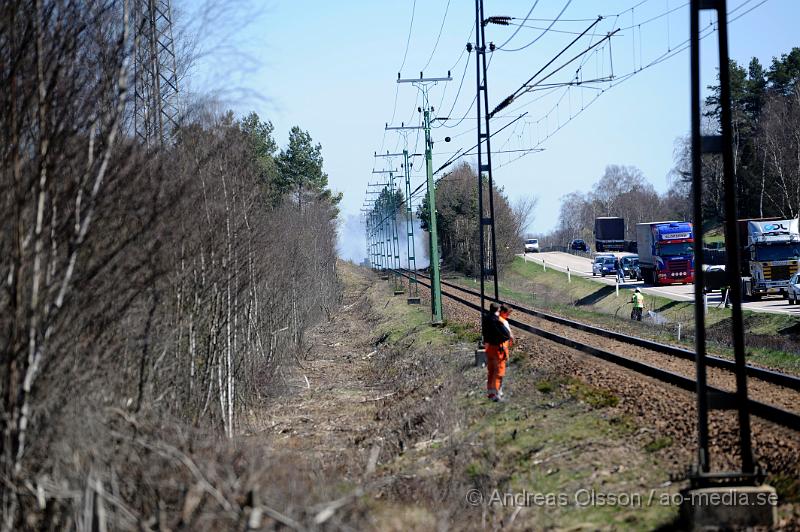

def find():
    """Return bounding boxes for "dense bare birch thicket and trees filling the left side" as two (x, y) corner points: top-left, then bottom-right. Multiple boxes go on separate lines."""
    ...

(0, 0), (341, 530)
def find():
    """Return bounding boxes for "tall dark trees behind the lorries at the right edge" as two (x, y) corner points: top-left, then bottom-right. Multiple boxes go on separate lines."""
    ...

(675, 47), (800, 223)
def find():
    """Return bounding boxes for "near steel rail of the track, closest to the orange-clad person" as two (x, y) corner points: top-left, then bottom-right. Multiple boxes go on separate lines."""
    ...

(397, 271), (800, 431)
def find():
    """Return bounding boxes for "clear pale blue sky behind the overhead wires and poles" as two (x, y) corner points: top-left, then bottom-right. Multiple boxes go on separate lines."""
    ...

(183, 0), (800, 260)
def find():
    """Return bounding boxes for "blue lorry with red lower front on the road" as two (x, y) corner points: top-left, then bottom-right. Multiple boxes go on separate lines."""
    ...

(636, 221), (694, 285)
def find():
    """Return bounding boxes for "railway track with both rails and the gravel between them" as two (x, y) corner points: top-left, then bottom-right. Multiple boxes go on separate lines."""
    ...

(397, 270), (800, 432)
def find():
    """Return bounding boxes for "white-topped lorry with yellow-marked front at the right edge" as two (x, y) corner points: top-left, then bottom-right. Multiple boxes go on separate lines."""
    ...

(738, 218), (800, 299)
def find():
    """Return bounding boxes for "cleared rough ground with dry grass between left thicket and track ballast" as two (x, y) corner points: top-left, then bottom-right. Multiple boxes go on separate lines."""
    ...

(240, 265), (793, 530)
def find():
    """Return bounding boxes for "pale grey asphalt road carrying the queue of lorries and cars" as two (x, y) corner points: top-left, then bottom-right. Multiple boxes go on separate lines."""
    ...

(520, 251), (800, 316)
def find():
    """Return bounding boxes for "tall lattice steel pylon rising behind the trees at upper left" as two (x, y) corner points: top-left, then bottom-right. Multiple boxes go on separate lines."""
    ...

(133, 0), (179, 145)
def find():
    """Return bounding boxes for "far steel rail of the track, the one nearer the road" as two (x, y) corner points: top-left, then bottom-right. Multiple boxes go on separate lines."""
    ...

(404, 273), (800, 391)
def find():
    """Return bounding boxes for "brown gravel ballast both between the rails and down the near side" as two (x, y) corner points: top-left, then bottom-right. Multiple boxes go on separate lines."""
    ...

(400, 276), (800, 492)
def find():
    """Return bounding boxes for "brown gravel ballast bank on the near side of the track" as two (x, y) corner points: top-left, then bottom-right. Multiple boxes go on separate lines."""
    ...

(404, 268), (800, 526)
